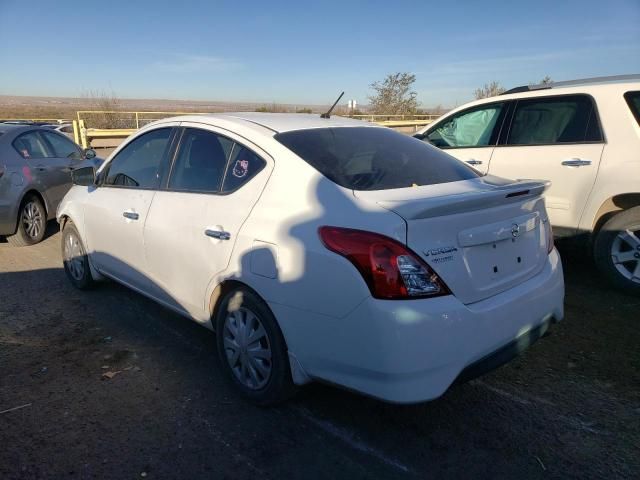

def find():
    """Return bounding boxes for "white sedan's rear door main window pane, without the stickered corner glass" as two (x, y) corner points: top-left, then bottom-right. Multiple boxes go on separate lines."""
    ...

(169, 128), (233, 193)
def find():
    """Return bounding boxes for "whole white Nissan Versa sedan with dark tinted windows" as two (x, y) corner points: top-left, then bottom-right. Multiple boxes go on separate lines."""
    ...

(57, 113), (564, 404)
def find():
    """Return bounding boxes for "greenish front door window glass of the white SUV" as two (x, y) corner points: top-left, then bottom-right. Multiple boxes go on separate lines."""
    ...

(426, 103), (504, 148)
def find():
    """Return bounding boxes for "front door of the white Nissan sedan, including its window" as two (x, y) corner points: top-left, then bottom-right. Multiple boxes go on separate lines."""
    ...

(84, 126), (178, 293)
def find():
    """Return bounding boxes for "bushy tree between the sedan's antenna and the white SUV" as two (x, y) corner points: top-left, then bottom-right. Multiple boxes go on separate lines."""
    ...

(368, 72), (418, 115)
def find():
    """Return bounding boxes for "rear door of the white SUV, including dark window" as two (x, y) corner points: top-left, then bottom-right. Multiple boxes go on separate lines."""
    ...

(489, 95), (604, 234)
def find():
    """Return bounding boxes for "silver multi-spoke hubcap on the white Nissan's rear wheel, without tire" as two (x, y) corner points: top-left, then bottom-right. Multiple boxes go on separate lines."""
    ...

(222, 307), (272, 390)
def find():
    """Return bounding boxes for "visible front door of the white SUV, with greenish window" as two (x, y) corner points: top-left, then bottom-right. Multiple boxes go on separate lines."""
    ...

(423, 101), (507, 173)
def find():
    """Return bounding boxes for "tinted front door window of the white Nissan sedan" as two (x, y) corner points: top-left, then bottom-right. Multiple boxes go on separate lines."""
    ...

(104, 128), (171, 188)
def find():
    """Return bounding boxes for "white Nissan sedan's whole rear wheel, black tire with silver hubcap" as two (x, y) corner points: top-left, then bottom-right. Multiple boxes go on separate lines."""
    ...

(215, 288), (295, 406)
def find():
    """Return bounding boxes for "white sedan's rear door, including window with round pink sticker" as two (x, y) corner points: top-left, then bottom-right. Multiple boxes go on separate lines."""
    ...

(144, 123), (272, 321)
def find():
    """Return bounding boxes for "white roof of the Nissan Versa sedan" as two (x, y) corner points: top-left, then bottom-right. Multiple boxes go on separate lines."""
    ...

(154, 112), (375, 133)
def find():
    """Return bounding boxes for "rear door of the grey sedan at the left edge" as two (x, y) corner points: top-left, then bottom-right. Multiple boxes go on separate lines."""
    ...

(13, 130), (71, 208)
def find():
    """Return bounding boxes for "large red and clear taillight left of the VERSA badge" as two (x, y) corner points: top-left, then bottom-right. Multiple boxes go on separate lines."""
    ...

(318, 227), (450, 300)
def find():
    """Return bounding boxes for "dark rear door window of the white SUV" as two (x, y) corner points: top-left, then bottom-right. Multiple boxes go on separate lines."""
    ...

(507, 95), (602, 145)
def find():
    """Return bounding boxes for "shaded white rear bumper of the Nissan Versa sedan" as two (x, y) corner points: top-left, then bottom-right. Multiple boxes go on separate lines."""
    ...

(271, 250), (564, 403)
